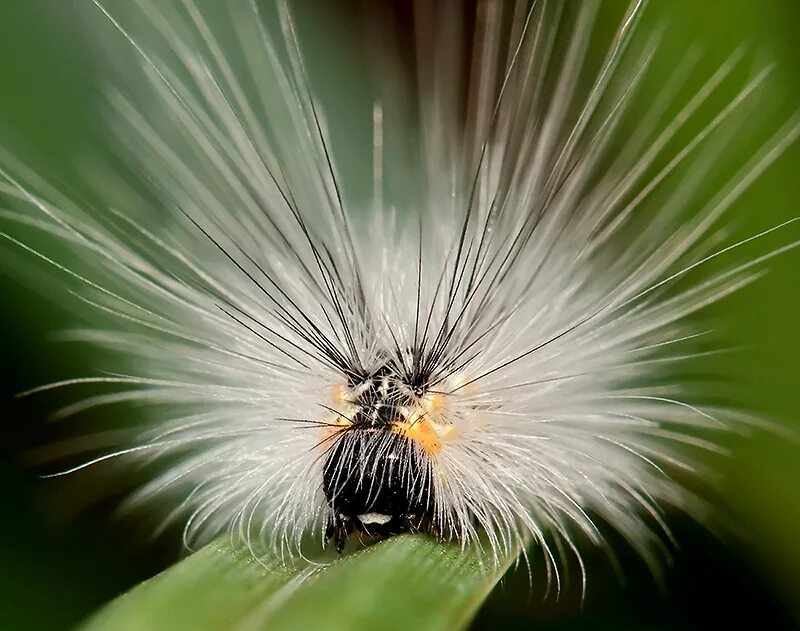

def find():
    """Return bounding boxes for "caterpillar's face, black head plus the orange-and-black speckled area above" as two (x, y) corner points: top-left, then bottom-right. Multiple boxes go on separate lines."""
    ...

(323, 362), (453, 551)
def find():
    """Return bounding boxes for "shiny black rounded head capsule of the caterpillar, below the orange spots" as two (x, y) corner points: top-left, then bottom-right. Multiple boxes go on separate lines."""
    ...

(323, 428), (433, 551)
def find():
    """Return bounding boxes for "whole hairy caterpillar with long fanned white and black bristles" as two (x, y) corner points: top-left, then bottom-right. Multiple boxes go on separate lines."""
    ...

(2, 1), (800, 592)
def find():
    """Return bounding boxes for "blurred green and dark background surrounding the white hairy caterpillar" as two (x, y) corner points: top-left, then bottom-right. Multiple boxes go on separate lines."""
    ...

(0, 0), (800, 629)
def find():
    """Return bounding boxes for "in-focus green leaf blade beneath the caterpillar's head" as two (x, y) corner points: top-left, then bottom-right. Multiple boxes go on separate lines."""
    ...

(78, 535), (515, 631)
